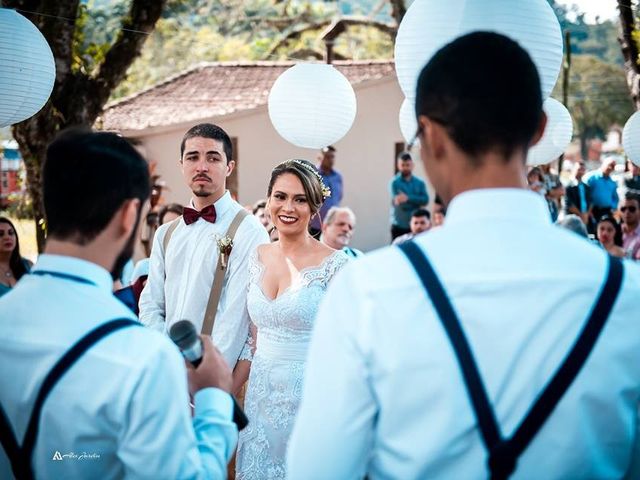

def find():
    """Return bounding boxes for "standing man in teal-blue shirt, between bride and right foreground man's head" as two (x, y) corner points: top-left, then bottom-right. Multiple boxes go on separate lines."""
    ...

(389, 152), (429, 241)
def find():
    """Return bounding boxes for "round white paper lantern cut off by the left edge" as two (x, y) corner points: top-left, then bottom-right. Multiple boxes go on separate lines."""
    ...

(0, 8), (56, 127)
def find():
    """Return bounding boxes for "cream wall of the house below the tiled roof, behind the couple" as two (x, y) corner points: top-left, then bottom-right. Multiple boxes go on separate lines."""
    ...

(131, 77), (433, 251)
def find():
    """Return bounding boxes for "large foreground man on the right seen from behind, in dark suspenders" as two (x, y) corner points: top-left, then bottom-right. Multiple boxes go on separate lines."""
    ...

(288, 32), (640, 480)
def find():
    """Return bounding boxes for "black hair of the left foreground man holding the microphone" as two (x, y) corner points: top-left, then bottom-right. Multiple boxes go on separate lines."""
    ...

(42, 128), (151, 245)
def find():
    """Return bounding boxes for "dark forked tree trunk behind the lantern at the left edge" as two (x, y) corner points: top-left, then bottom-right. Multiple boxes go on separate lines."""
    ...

(3, 0), (166, 252)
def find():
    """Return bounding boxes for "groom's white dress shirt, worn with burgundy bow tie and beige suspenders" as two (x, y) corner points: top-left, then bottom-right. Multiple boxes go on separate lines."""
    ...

(139, 192), (269, 368)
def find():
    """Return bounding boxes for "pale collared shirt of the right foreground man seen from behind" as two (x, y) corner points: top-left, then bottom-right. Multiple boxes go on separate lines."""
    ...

(287, 189), (640, 480)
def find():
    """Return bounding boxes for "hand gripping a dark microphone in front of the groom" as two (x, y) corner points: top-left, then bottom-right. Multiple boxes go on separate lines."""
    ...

(169, 320), (249, 430)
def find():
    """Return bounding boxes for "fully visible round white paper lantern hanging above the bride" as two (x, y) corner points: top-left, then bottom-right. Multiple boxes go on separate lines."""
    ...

(269, 63), (356, 149)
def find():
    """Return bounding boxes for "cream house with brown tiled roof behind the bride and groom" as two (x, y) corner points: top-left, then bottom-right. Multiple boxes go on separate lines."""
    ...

(97, 60), (433, 250)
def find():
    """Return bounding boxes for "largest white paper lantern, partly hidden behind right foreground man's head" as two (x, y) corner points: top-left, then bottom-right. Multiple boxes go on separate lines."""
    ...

(395, 0), (562, 99)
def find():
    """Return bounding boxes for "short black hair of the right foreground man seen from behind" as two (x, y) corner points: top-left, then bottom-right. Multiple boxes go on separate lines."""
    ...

(415, 32), (542, 162)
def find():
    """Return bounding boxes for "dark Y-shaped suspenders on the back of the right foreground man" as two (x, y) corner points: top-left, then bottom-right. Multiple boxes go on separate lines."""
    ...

(399, 241), (623, 480)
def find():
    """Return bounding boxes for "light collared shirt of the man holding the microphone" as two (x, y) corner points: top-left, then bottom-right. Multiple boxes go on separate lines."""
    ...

(0, 254), (237, 479)
